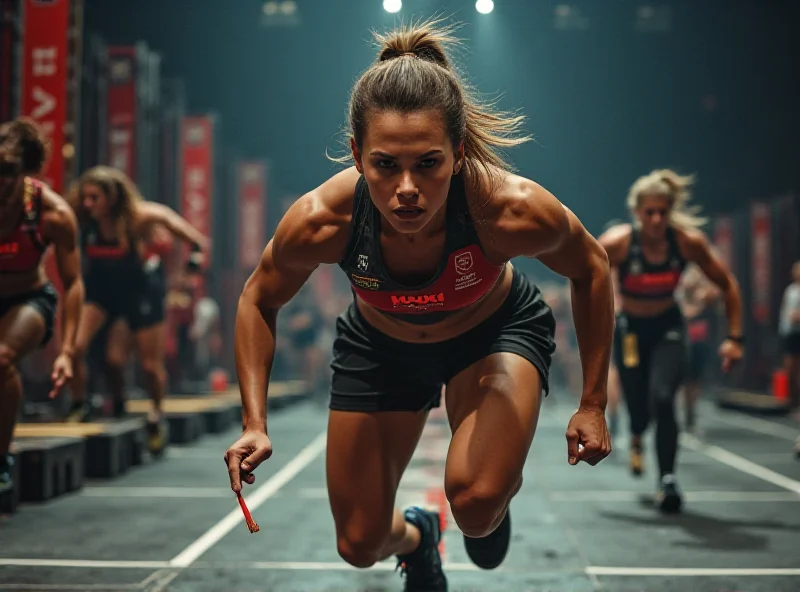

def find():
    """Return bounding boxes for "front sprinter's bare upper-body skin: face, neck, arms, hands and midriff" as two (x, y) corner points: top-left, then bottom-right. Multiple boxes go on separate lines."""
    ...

(226, 111), (614, 491)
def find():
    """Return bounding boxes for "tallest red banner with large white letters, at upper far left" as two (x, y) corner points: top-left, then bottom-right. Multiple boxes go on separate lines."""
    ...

(21, 0), (69, 192)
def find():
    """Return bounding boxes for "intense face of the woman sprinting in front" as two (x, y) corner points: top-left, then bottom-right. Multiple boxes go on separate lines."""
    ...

(351, 111), (463, 234)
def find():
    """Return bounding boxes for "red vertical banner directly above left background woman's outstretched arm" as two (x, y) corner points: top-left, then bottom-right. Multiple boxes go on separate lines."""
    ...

(181, 116), (214, 280)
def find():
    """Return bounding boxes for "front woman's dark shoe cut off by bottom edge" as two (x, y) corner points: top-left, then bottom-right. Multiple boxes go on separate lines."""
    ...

(397, 507), (447, 592)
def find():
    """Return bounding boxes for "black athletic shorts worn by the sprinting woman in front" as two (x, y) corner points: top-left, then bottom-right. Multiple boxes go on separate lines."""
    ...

(330, 268), (555, 412)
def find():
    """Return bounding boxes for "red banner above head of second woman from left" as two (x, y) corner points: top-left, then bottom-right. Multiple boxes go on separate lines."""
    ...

(106, 47), (136, 180)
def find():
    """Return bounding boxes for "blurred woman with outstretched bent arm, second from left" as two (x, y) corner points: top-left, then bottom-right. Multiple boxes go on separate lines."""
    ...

(68, 166), (206, 454)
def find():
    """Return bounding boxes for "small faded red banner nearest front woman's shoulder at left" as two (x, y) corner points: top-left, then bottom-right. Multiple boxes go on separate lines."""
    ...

(236, 162), (267, 270)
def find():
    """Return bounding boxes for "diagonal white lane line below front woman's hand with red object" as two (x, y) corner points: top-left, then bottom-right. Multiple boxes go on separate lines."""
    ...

(169, 432), (327, 567)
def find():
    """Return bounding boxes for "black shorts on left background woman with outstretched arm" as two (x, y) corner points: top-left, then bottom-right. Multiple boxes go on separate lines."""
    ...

(86, 270), (166, 333)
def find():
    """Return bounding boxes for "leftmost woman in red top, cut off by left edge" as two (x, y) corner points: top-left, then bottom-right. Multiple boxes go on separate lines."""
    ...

(0, 118), (84, 492)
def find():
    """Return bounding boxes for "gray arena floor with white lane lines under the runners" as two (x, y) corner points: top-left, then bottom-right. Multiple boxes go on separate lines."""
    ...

(0, 394), (800, 592)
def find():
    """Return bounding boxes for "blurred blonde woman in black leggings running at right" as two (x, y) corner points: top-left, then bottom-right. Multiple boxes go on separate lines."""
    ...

(600, 170), (743, 512)
